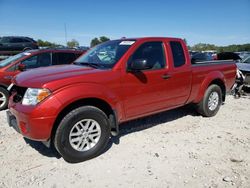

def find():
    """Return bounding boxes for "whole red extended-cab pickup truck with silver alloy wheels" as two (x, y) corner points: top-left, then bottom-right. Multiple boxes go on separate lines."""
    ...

(7, 38), (236, 162)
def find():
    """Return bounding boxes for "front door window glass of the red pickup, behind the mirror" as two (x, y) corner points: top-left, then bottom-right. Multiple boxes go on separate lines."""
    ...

(130, 42), (166, 70)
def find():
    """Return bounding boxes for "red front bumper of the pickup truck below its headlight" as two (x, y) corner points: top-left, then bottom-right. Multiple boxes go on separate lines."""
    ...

(7, 97), (61, 142)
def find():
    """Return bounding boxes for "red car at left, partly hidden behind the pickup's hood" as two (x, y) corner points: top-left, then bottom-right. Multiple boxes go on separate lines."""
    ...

(0, 49), (85, 110)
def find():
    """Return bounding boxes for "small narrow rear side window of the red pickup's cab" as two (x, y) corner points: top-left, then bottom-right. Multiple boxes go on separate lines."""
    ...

(170, 41), (186, 68)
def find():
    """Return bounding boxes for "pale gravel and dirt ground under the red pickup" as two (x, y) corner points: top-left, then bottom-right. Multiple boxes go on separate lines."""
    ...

(0, 96), (250, 188)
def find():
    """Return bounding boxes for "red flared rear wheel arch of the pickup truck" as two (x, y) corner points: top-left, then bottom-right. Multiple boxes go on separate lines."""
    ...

(194, 71), (226, 103)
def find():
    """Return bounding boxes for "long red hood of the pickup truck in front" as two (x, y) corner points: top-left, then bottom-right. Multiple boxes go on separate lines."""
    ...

(13, 65), (108, 90)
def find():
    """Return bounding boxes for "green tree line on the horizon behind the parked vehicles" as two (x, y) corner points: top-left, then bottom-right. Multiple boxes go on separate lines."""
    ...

(37, 36), (250, 52)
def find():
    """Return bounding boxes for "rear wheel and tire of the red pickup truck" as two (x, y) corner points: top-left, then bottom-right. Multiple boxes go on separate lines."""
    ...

(197, 84), (222, 117)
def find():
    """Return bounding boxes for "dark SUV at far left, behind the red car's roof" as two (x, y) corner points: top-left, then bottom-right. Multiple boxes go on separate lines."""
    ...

(0, 36), (38, 55)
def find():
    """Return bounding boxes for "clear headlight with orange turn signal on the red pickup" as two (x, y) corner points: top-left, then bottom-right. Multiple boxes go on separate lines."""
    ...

(22, 88), (51, 105)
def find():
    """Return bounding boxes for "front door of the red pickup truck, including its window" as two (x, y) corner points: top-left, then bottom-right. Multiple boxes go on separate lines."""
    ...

(122, 41), (170, 119)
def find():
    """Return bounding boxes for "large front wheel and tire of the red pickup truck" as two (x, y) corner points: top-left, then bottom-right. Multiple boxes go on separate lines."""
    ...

(54, 106), (110, 163)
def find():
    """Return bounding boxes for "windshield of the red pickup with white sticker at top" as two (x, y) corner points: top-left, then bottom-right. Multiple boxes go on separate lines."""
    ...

(75, 40), (135, 68)
